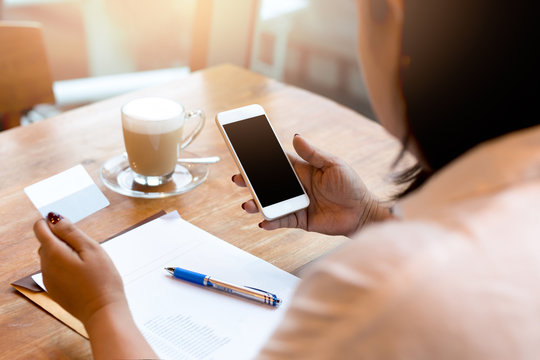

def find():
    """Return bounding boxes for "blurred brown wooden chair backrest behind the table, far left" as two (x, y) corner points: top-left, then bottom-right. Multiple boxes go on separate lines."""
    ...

(0, 21), (55, 129)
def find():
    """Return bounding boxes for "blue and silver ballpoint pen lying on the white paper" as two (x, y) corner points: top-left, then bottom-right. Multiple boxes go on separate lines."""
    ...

(165, 267), (281, 306)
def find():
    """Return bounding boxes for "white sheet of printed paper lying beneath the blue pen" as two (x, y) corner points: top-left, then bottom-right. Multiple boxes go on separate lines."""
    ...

(33, 212), (299, 359)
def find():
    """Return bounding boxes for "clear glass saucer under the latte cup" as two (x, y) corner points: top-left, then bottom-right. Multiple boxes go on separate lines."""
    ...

(100, 151), (208, 199)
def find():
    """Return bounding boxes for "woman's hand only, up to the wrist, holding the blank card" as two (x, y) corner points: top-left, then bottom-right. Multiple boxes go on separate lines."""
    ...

(34, 213), (127, 324)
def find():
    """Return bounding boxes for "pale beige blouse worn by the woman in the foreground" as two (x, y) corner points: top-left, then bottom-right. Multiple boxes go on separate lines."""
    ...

(260, 127), (540, 359)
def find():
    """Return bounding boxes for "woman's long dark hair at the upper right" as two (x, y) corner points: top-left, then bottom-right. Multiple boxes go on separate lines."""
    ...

(398, 0), (540, 196)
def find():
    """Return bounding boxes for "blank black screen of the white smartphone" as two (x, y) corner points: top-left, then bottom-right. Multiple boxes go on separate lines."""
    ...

(223, 115), (304, 207)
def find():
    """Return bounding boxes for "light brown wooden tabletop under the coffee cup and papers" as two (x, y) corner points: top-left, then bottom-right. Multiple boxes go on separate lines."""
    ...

(0, 65), (400, 359)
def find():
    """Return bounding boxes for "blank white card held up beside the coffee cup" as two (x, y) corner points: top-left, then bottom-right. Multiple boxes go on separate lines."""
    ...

(24, 165), (110, 222)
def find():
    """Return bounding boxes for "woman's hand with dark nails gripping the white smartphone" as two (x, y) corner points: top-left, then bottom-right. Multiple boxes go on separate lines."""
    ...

(233, 135), (392, 235)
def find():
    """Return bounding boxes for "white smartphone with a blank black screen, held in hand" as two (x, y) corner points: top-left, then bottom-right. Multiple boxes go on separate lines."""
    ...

(216, 104), (309, 220)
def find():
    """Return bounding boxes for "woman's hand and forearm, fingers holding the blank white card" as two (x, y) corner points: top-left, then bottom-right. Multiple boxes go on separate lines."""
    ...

(34, 213), (157, 360)
